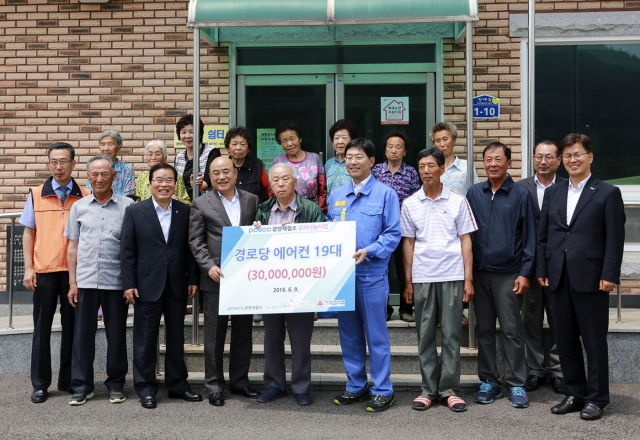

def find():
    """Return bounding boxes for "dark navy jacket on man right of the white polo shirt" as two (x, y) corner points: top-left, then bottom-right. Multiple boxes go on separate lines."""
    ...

(467, 175), (536, 278)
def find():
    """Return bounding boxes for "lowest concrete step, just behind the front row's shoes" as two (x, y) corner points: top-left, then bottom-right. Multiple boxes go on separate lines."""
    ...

(158, 371), (480, 392)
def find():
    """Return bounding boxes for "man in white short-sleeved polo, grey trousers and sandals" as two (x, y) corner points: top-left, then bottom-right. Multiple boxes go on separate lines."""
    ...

(400, 148), (478, 412)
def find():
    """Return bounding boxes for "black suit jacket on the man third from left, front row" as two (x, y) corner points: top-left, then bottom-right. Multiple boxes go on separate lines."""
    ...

(120, 199), (198, 301)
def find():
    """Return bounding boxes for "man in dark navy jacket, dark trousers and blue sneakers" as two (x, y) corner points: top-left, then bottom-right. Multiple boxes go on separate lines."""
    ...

(467, 142), (536, 408)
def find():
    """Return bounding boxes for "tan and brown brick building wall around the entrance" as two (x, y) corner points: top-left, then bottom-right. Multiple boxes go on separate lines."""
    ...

(0, 0), (640, 288)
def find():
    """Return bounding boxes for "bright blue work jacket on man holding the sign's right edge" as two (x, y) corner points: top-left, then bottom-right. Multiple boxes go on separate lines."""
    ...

(327, 176), (401, 276)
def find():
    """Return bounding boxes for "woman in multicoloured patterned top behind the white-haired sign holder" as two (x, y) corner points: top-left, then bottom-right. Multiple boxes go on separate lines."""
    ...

(269, 120), (327, 212)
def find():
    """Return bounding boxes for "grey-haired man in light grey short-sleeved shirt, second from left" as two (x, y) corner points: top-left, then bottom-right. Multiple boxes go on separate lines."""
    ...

(64, 156), (133, 405)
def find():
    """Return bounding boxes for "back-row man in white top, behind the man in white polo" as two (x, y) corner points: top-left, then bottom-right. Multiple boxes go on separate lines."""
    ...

(429, 121), (480, 196)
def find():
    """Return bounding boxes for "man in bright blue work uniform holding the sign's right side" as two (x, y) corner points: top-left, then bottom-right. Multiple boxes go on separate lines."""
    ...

(327, 138), (401, 412)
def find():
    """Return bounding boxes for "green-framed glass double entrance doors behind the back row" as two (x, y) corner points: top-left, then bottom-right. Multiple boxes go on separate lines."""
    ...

(237, 73), (436, 170)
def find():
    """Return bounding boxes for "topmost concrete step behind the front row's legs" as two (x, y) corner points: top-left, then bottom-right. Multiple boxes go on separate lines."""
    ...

(170, 315), (469, 347)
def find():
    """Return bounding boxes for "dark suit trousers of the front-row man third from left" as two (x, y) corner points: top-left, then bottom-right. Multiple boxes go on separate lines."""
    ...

(133, 278), (191, 397)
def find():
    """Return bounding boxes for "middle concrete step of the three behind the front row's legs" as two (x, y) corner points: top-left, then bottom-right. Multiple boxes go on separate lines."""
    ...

(160, 344), (478, 375)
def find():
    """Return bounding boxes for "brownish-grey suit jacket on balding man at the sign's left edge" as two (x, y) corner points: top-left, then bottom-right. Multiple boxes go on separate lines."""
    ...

(189, 189), (258, 291)
